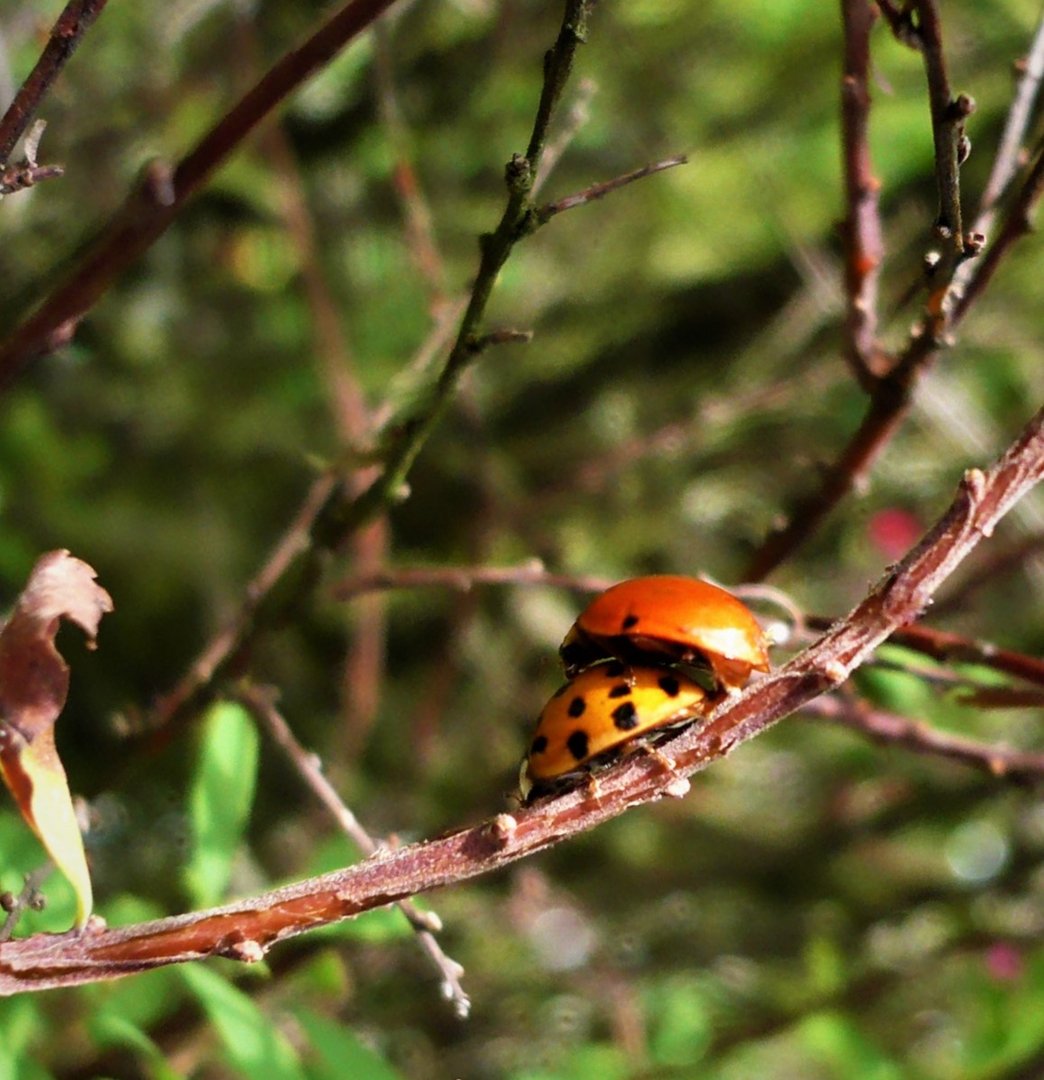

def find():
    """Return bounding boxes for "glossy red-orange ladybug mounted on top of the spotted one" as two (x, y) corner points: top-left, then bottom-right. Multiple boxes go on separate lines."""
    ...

(559, 575), (769, 689)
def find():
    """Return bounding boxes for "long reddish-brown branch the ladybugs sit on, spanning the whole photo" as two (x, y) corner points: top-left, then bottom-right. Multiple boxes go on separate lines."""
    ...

(0, 399), (1044, 995)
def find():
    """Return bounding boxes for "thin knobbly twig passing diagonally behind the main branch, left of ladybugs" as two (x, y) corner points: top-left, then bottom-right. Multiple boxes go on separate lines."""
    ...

(236, 686), (471, 1020)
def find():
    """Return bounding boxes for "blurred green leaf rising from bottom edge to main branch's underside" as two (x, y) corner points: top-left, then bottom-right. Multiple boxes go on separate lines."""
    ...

(180, 964), (306, 1080)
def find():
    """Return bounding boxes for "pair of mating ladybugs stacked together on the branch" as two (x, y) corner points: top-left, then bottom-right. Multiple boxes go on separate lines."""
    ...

(519, 575), (769, 802)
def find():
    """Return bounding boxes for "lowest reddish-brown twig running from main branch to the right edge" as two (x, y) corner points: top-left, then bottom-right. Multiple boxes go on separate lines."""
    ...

(802, 694), (1044, 782)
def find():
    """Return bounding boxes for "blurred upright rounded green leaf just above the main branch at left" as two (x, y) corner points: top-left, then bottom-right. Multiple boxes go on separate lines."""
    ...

(185, 702), (258, 907)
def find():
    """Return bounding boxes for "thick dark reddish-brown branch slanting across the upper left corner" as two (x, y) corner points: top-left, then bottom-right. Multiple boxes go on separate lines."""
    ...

(0, 0), (403, 390)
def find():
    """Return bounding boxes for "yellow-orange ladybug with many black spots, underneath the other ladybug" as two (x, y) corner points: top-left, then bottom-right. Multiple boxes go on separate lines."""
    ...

(518, 661), (720, 802)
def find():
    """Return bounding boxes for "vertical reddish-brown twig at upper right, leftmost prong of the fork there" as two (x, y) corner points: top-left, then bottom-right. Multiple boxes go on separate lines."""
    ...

(841, 0), (885, 390)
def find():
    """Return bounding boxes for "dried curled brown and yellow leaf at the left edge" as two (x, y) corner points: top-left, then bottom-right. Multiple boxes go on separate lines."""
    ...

(0, 551), (112, 927)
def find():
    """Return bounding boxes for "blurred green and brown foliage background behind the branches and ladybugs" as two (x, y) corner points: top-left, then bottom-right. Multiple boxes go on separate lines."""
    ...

(0, 0), (1044, 1080)
